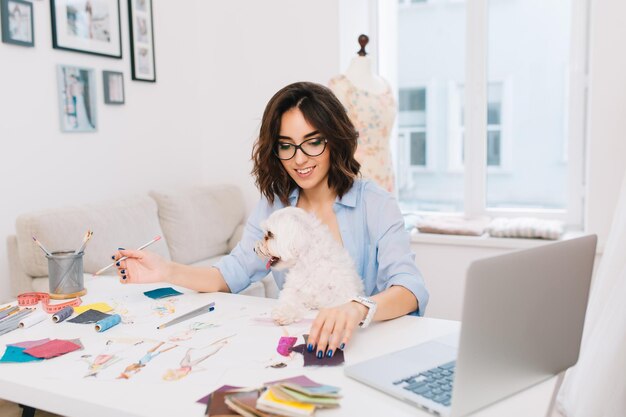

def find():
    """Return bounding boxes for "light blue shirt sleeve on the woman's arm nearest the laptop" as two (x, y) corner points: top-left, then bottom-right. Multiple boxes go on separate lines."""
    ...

(368, 190), (429, 316)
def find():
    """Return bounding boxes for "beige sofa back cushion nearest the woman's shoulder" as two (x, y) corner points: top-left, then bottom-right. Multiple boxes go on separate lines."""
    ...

(150, 186), (245, 264)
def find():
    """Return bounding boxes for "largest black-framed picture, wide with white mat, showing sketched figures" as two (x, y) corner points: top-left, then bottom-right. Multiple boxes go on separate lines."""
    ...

(50, 0), (122, 58)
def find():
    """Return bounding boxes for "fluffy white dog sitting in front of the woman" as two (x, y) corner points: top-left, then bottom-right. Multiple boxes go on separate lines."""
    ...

(254, 207), (363, 325)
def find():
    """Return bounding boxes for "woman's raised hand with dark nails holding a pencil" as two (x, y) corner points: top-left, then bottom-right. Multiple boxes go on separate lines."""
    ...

(113, 249), (171, 284)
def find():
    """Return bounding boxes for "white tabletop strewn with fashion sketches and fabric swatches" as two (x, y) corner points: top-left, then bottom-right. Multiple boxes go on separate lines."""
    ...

(0, 277), (556, 417)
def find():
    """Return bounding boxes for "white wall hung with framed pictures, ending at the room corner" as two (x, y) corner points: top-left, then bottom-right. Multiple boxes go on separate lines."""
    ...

(0, 1), (210, 300)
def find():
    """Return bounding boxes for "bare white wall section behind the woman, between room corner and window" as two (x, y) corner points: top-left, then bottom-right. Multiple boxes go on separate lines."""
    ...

(196, 0), (339, 208)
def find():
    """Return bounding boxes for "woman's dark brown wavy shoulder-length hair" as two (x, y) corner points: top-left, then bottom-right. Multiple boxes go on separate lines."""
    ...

(252, 82), (361, 205)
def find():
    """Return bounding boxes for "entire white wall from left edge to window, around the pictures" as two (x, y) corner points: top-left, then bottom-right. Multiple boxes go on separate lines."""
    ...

(0, 0), (339, 302)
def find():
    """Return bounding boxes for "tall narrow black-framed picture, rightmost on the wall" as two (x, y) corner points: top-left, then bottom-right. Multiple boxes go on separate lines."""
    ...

(128, 0), (156, 82)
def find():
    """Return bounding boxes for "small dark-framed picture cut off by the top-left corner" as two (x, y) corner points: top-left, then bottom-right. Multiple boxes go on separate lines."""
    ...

(0, 0), (35, 46)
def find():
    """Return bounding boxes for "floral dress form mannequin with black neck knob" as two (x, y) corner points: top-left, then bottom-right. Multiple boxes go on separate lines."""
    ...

(328, 35), (396, 192)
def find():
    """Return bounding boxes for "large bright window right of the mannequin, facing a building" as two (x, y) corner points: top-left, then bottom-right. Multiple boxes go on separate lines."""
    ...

(390, 0), (587, 227)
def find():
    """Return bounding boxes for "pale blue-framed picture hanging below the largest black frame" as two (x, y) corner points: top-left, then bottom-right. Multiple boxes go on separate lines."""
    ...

(57, 65), (97, 132)
